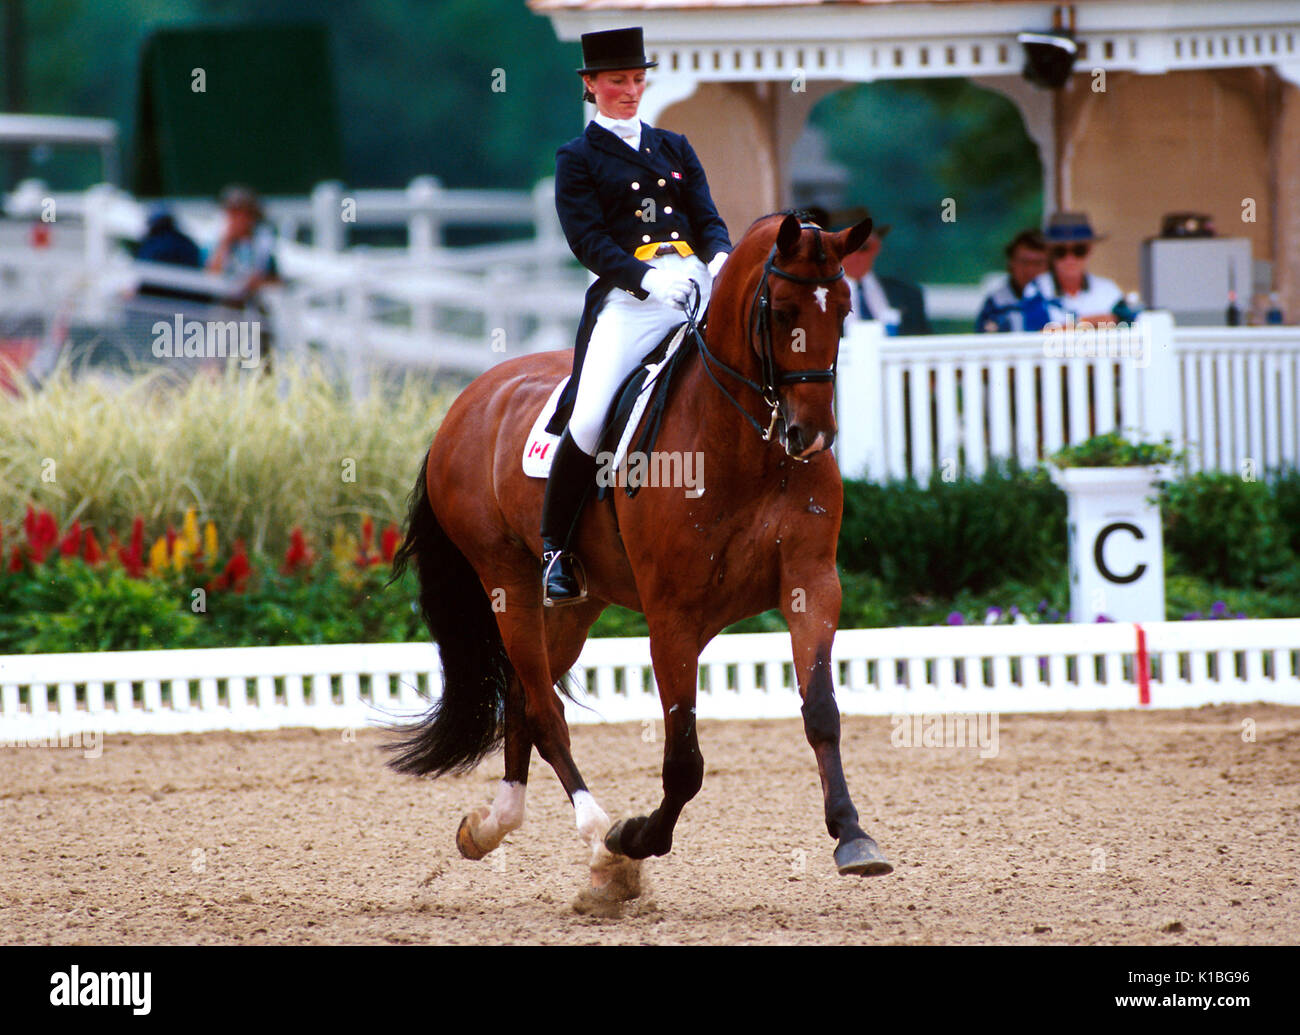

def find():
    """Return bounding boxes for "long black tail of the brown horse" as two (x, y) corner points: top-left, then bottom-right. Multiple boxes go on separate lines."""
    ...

(385, 454), (514, 776)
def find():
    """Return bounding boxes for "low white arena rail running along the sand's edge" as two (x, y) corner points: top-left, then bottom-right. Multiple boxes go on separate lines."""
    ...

(0, 619), (1300, 745)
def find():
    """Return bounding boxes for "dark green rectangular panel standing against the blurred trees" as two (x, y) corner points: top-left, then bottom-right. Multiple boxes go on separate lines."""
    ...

(131, 25), (343, 198)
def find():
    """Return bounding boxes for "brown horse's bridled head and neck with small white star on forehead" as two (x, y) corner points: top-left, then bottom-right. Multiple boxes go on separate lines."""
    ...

(710, 213), (871, 460)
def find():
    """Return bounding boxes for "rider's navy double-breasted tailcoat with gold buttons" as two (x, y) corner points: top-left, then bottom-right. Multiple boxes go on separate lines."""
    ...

(546, 121), (731, 434)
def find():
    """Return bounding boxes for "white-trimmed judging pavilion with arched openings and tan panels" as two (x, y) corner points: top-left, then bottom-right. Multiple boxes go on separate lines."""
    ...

(528, 0), (1300, 313)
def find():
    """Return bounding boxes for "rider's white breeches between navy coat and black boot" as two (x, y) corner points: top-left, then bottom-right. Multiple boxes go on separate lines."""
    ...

(568, 252), (712, 456)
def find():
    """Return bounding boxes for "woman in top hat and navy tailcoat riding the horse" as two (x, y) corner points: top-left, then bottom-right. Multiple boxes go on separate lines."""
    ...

(541, 27), (732, 607)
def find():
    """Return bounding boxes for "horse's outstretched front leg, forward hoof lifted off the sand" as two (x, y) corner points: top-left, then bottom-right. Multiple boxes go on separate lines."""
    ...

(781, 564), (893, 876)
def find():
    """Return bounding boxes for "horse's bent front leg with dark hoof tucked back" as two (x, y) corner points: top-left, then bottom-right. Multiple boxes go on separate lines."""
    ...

(605, 622), (705, 859)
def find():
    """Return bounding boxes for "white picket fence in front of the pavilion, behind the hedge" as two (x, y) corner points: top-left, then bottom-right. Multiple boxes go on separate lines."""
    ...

(836, 312), (1300, 481)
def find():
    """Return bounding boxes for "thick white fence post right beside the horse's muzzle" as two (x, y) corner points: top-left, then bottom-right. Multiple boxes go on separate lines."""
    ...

(835, 320), (889, 478)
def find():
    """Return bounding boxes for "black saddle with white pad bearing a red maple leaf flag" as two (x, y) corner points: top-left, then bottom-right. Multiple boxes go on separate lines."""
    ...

(523, 322), (690, 501)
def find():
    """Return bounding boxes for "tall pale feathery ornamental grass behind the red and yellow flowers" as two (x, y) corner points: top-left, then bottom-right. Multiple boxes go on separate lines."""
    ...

(0, 364), (454, 555)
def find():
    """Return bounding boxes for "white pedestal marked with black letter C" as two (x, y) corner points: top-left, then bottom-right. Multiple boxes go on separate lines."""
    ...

(1049, 465), (1169, 622)
